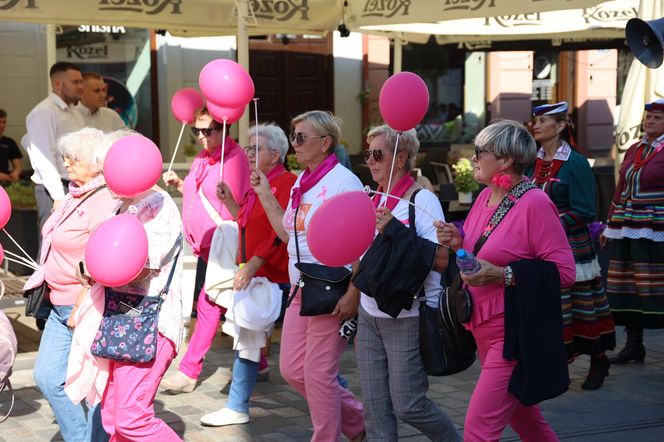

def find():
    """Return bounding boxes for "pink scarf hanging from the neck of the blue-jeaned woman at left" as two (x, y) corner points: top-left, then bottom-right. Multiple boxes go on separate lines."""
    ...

(23, 175), (106, 290)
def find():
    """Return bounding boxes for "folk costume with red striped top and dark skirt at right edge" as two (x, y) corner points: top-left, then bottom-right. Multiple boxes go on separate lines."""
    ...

(604, 135), (664, 328)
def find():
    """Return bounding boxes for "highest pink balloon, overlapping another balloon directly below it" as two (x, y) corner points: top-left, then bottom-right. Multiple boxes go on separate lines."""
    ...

(198, 58), (255, 108)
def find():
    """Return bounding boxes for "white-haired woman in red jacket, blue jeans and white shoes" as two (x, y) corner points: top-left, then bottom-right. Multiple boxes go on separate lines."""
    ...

(201, 124), (297, 426)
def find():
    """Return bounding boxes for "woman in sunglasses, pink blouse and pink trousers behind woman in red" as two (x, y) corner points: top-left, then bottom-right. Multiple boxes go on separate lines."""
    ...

(161, 108), (267, 393)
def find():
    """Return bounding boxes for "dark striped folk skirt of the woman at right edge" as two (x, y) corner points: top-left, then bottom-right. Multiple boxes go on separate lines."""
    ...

(606, 238), (664, 328)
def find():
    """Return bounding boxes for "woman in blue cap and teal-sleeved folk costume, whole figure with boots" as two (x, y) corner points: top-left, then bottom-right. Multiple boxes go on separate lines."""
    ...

(526, 101), (616, 390)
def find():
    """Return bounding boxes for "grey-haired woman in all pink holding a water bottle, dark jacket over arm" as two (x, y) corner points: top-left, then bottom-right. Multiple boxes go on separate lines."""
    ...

(436, 120), (576, 442)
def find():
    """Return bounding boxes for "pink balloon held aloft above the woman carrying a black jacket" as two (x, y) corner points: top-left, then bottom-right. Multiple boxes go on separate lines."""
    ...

(378, 72), (429, 131)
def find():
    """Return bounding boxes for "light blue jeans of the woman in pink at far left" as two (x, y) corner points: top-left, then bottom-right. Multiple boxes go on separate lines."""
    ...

(33, 305), (108, 442)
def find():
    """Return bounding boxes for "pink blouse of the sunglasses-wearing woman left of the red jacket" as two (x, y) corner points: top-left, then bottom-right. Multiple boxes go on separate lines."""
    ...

(182, 137), (251, 261)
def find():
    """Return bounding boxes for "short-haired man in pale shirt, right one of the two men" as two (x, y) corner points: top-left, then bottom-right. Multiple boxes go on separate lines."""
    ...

(76, 72), (127, 132)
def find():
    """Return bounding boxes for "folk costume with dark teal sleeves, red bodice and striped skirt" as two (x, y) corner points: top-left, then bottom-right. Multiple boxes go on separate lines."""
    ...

(526, 141), (616, 359)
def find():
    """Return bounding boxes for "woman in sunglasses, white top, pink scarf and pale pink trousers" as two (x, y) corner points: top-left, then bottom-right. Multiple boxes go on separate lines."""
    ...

(251, 111), (364, 442)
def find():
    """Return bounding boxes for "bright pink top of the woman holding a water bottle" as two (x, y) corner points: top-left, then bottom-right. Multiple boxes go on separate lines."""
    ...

(463, 188), (576, 330)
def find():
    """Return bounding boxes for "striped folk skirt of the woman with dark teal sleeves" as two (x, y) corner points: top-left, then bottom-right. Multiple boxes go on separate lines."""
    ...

(561, 276), (616, 361)
